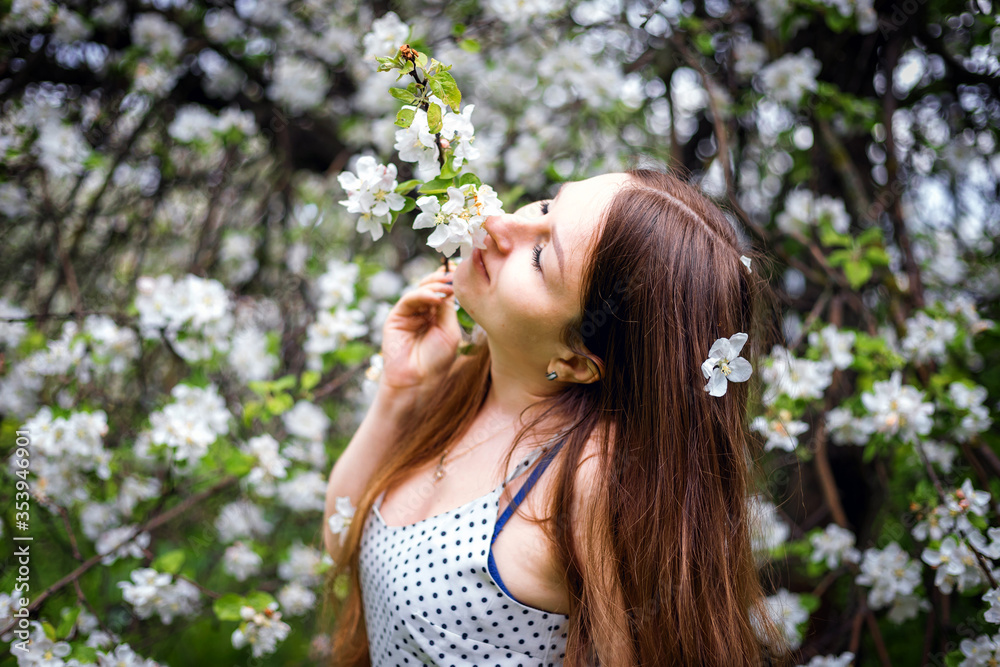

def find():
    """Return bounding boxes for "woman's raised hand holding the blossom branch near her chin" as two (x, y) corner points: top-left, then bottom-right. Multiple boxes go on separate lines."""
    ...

(381, 262), (462, 400)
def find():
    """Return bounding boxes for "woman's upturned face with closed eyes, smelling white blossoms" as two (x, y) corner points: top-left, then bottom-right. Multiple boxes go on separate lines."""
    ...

(454, 174), (628, 363)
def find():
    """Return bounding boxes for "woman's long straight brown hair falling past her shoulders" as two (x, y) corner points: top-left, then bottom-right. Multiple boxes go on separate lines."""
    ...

(326, 169), (789, 667)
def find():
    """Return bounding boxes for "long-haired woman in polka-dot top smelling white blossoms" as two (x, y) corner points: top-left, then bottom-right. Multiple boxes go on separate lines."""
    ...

(324, 170), (792, 667)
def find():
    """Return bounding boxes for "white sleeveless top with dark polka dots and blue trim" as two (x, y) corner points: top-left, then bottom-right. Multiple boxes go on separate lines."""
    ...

(359, 441), (569, 667)
